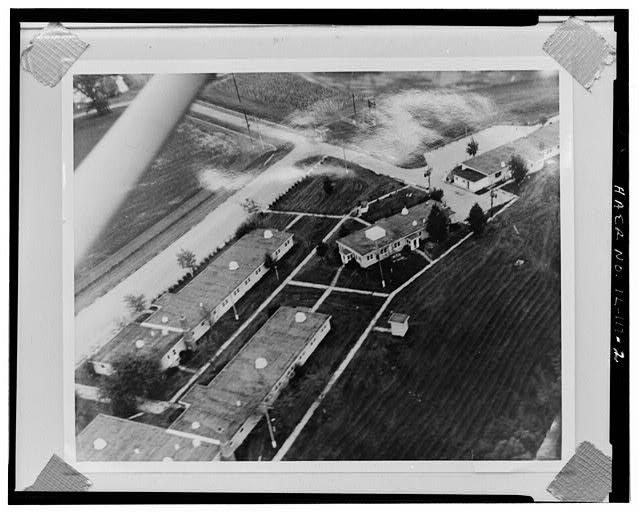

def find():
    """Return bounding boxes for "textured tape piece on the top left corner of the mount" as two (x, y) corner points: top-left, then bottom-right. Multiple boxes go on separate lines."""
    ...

(20, 23), (89, 87)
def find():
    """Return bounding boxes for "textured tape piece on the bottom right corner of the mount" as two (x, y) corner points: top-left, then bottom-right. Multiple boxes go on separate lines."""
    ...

(547, 441), (611, 502)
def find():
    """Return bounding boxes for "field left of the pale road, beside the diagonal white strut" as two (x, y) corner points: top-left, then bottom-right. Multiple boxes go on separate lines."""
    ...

(75, 118), (283, 308)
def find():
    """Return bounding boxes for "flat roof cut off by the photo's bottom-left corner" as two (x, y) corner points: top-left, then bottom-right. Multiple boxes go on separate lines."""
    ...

(76, 414), (220, 462)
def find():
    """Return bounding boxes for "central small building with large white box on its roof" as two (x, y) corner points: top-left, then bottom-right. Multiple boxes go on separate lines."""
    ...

(337, 200), (451, 268)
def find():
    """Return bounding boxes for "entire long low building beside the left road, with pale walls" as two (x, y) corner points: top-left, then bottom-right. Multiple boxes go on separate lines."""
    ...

(90, 229), (293, 375)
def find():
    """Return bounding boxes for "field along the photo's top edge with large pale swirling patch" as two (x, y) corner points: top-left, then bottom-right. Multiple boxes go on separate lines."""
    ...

(201, 72), (559, 168)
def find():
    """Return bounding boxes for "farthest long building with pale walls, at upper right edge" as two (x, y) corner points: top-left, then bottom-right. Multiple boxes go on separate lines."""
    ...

(452, 122), (560, 193)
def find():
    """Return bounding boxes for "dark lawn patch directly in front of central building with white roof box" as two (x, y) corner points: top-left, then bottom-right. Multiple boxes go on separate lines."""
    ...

(336, 248), (429, 293)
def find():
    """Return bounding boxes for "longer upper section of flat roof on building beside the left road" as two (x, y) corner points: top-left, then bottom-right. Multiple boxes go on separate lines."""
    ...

(143, 229), (293, 328)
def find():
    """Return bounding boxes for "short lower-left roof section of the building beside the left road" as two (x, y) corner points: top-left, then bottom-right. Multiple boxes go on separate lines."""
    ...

(90, 322), (182, 363)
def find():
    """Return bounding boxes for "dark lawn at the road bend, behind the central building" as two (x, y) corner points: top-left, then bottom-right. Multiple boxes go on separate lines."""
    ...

(271, 157), (404, 214)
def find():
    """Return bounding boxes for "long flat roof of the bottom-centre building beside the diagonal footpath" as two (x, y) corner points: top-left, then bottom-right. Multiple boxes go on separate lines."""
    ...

(171, 307), (331, 440)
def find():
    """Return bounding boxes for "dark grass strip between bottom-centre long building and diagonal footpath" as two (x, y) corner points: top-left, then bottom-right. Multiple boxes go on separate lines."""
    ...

(236, 292), (384, 460)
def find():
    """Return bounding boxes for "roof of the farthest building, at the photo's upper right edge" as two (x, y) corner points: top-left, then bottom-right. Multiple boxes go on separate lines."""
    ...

(454, 123), (560, 178)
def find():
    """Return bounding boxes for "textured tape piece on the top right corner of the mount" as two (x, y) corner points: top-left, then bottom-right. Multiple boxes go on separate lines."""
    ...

(542, 17), (616, 90)
